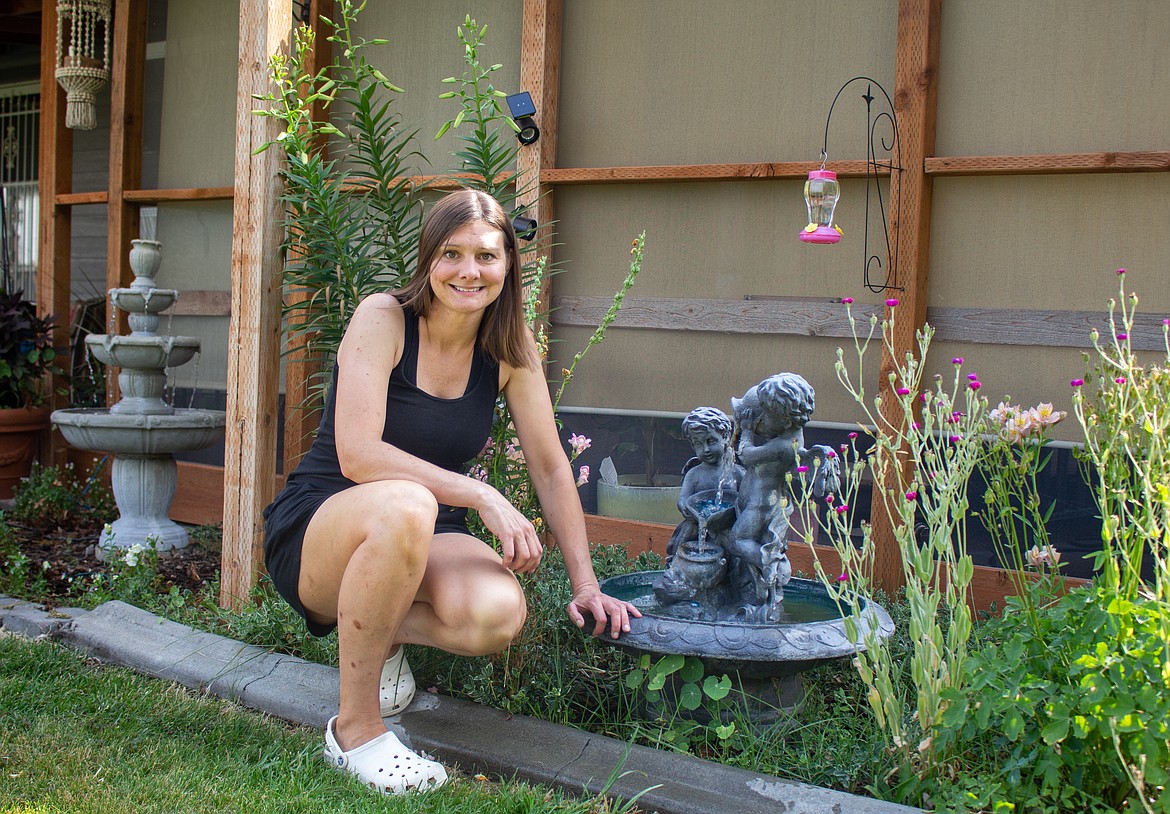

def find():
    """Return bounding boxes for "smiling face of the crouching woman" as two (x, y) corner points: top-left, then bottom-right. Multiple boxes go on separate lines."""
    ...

(431, 221), (508, 313)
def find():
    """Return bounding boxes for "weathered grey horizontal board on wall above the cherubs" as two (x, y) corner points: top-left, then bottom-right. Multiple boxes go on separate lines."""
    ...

(552, 296), (1165, 351)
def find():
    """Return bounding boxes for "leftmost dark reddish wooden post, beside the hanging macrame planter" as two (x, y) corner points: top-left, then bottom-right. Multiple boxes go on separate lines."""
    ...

(36, 4), (73, 464)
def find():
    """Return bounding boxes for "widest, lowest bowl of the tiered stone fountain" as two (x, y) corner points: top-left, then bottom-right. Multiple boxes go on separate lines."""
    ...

(51, 408), (227, 455)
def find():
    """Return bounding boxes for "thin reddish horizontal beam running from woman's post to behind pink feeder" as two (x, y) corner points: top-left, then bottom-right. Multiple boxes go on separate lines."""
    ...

(541, 160), (889, 186)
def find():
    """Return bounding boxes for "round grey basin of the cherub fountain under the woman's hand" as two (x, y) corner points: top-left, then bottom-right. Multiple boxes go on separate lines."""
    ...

(601, 571), (894, 677)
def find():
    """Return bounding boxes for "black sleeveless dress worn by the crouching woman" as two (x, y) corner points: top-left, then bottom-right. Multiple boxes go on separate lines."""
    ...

(264, 306), (500, 636)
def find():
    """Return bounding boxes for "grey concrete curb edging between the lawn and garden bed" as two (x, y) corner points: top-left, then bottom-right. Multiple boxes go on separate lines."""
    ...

(0, 596), (918, 814)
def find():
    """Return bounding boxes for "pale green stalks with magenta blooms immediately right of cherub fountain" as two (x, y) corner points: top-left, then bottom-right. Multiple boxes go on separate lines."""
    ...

(817, 299), (986, 771)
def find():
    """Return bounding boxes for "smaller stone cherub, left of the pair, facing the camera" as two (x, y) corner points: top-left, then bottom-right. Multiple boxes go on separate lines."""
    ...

(666, 407), (743, 560)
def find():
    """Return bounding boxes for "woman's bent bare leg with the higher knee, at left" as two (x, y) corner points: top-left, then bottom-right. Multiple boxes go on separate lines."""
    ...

(298, 481), (438, 751)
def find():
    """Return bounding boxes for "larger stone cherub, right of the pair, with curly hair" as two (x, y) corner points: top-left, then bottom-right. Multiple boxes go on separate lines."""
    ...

(725, 373), (840, 622)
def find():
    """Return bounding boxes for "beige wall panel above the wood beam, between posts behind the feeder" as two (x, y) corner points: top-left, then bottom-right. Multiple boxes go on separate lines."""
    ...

(557, 0), (897, 167)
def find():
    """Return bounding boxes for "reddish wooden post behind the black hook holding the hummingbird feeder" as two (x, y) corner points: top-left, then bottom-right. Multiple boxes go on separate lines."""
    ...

(869, 0), (942, 594)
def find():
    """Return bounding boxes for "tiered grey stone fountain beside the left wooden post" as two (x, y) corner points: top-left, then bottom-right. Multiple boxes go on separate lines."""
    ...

(53, 240), (226, 557)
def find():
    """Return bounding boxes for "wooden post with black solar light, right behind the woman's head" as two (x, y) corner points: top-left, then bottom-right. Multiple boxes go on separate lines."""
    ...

(517, 0), (562, 327)
